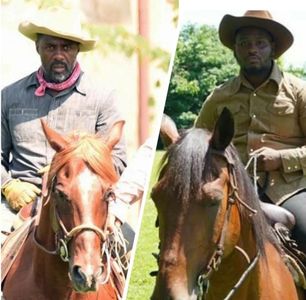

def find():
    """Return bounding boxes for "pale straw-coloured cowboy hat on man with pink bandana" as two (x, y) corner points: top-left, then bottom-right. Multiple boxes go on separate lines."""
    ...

(18, 8), (97, 51)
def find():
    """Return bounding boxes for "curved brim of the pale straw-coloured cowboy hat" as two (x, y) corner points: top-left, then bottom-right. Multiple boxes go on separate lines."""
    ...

(18, 22), (97, 52)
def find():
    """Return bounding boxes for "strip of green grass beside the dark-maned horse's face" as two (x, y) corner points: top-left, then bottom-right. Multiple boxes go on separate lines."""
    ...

(127, 151), (164, 300)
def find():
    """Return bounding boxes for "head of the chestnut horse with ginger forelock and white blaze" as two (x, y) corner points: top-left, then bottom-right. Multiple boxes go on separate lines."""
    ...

(35, 121), (124, 292)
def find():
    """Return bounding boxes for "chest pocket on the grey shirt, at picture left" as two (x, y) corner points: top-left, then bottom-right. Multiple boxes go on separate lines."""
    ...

(9, 108), (41, 142)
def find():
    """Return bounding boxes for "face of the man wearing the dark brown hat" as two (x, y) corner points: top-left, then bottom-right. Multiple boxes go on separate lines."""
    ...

(234, 27), (274, 75)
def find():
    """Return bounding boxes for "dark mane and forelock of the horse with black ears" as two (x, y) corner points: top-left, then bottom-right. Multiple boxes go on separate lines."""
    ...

(160, 128), (279, 257)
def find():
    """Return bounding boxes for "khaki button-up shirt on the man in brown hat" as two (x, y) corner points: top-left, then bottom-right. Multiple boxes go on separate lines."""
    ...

(195, 64), (306, 204)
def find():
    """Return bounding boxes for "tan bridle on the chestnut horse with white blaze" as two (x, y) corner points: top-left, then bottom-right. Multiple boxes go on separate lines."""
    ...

(33, 176), (115, 282)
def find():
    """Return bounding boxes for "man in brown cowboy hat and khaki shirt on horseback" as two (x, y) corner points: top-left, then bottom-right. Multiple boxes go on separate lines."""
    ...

(195, 10), (306, 252)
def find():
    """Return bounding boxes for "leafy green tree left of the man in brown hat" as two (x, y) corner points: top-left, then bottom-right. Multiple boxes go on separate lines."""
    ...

(165, 24), (238, 128)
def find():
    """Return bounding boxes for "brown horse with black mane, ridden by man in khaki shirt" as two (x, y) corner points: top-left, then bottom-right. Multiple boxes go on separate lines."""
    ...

(152, 109), (297, 300)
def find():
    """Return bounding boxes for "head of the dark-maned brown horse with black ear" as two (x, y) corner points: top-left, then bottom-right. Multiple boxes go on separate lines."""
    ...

(152, 109), (244, 299)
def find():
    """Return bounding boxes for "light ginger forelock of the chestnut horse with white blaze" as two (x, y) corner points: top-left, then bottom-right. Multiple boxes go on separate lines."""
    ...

(48, 132), (118, 188)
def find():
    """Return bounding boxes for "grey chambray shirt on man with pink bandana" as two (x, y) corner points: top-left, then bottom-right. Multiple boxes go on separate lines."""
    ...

(1, 73), (126, 186)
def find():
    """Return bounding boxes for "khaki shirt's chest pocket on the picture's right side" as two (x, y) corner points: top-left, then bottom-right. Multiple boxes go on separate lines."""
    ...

(266, 99), (300, 137)
